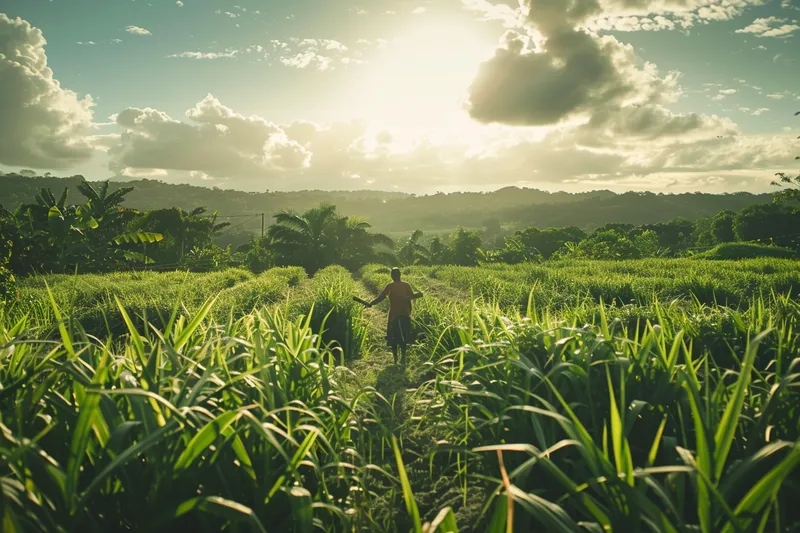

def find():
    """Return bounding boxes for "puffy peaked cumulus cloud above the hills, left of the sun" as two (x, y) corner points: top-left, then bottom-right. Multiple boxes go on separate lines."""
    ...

(108, 94), (311, 180)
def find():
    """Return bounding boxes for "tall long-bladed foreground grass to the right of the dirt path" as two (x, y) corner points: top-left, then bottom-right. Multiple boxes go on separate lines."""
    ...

(406, 300), (800, 533)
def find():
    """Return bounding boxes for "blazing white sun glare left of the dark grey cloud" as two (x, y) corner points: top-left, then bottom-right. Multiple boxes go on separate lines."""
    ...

(350, 16), (494, 140)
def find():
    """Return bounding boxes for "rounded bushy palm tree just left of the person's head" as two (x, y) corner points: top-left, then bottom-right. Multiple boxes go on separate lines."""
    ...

(267, 203), (392, 273)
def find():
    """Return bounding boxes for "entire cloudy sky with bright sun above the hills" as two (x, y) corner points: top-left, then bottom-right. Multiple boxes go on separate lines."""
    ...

(0, 0), (800, 194)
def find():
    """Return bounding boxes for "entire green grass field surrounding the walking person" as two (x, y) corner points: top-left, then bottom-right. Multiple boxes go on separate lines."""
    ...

(0, 259), (800, 533)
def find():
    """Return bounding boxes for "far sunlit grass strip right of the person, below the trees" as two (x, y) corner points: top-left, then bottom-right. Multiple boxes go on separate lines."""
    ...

(418, 259), (800, 312)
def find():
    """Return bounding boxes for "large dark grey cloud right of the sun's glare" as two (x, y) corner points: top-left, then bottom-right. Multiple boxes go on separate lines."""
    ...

(467, 0), (679, 126)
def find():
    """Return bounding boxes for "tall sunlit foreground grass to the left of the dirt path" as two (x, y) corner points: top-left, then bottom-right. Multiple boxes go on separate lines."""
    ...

(0, 301), (394, 532)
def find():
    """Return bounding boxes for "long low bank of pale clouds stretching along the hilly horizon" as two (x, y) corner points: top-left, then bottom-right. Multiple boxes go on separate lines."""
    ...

(95, 89), (796, 192)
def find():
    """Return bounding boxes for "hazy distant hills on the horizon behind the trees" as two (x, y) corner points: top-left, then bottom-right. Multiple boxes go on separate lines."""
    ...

(0, 174), (771, 233)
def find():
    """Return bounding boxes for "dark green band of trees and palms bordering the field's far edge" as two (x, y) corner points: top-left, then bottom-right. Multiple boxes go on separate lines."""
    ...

(0, 174), (800, 296)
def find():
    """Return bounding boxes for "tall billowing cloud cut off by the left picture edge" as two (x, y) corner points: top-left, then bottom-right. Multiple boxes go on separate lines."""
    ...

(0, 13), (94, 169)
